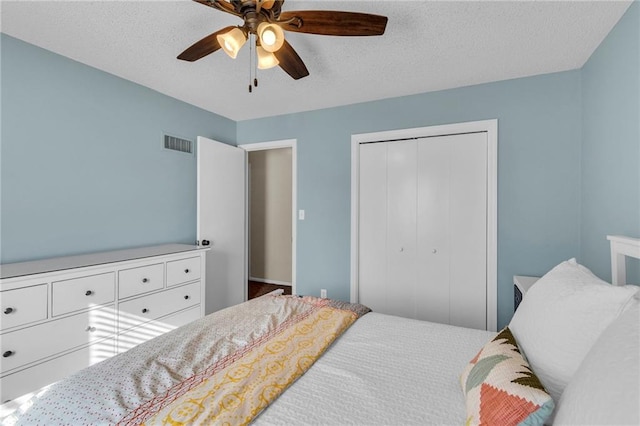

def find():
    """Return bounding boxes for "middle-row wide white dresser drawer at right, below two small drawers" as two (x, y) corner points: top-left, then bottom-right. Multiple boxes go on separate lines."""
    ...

(118, 281), (200, 332)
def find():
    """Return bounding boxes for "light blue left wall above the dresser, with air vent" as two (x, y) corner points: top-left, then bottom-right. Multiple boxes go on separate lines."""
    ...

(0, 34), (236, 263)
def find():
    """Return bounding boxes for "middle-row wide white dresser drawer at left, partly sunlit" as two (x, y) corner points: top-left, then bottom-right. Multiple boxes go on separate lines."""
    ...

(0, 307), (115, 373)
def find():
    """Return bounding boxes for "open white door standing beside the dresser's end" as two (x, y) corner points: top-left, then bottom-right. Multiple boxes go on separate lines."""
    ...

(197, 136), (246, 314)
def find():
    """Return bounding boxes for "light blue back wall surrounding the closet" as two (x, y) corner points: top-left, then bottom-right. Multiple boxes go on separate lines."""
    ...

(238, 71), (581, 325)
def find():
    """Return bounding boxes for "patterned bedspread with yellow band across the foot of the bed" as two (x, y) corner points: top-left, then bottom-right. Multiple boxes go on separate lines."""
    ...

(3, 295), (369, 425)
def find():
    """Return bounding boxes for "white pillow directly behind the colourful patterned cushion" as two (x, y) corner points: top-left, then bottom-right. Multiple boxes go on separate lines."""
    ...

(509, 259), (638, 408)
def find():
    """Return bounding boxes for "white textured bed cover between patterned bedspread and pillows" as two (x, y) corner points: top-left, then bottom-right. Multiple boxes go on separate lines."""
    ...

(254, 312), (496, 425)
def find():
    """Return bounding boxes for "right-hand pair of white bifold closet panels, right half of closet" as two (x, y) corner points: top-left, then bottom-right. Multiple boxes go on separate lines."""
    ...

(416, 133), (487, 329)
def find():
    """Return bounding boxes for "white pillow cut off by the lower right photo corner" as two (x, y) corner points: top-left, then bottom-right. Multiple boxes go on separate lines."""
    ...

(555, 300), (640, 425)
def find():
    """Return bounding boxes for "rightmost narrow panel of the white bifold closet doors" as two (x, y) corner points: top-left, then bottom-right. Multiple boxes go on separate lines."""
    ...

(447, 133), (487, 329)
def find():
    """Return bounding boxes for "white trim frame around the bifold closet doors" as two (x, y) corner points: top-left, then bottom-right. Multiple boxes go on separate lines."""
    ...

(351, 119), (498, 331)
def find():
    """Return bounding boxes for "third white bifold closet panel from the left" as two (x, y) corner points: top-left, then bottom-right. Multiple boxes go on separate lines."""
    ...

(415, 136), (454, 324)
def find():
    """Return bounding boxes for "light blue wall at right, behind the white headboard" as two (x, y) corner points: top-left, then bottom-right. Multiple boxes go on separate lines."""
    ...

(581, 1), (640, 283)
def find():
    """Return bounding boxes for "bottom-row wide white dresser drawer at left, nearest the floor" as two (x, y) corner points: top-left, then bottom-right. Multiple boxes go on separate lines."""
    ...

(0, 339), (115, 403)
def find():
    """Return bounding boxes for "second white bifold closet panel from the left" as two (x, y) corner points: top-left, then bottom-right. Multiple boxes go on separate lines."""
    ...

(381, 140), (417, 318)
